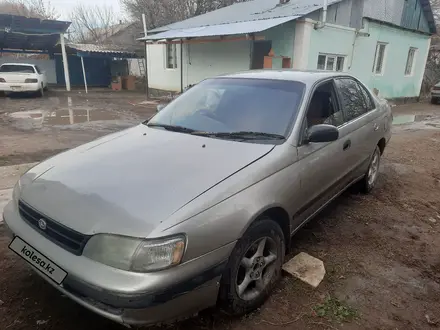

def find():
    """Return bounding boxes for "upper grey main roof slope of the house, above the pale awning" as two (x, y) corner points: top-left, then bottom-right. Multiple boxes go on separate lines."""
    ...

(149, 0), (343, 33)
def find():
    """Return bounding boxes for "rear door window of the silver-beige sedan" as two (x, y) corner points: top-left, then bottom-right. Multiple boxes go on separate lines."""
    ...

(336, 78), (368, 122)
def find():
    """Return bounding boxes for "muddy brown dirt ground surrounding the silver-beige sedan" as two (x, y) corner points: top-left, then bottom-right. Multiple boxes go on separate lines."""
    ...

(0, 95), (440, 330)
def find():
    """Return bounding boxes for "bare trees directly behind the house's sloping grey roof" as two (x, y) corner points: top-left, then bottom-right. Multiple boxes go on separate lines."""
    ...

(121, 0), (249, 29)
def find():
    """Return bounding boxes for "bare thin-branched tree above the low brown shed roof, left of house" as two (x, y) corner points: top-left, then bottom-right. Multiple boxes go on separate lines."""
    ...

(70, 4), (123, 44)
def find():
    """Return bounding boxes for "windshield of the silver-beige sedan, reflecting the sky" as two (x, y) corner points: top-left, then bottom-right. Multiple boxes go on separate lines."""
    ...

(147, 78), (304, 140)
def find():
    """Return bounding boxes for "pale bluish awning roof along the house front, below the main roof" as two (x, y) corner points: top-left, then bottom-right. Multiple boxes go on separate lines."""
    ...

(144, 16), (300, 40)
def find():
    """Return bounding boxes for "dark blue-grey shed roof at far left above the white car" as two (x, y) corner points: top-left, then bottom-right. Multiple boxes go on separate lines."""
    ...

(0, 14), (71, 51)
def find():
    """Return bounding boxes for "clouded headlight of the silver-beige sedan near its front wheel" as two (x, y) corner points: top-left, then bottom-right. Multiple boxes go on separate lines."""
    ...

(83, 234), (186, 273)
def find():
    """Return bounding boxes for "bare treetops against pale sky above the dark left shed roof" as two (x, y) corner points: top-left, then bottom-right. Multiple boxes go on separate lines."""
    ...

(0, 0), (59, 19)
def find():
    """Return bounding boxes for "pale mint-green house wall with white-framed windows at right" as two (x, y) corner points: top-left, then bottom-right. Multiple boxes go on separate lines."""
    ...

(307, 22), (430, 98)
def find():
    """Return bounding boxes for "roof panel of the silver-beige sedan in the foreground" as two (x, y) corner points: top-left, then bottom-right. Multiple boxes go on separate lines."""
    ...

(221, 69), (352, 85)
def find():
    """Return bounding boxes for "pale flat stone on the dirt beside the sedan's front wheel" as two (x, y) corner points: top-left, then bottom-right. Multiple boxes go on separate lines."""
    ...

(283, 252), (325, 288)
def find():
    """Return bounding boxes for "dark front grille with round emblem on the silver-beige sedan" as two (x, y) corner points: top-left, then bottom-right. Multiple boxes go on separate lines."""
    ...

(18, 201), (90, 256)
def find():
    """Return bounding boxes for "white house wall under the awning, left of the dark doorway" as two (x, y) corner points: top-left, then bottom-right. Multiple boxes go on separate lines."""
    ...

(147, 40), (251, 92)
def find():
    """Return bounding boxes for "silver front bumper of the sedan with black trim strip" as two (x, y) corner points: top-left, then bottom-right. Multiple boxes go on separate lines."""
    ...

(4, 202), (235, 325)
